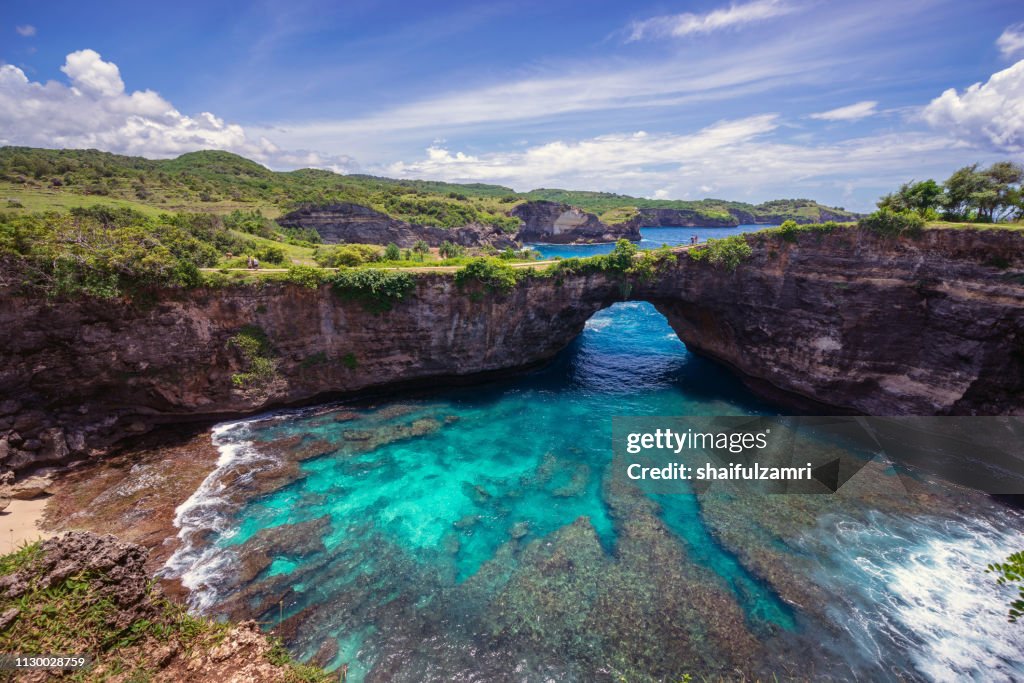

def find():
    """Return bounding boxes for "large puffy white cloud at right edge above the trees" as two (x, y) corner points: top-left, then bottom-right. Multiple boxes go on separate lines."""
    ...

(922, 59), (1024, 154)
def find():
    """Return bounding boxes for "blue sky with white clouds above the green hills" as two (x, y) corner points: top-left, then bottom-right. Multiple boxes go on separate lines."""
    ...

(0, 0), (1024, 211)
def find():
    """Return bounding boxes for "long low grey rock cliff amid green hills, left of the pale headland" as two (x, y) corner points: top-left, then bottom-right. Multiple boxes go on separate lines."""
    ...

(278, 203), (516, 249)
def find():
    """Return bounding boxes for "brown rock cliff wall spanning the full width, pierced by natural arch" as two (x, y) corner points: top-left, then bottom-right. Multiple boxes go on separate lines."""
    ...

(0, 228), (1024, 471)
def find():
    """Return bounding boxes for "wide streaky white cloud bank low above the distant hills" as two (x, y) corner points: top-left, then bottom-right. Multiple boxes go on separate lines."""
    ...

(376, 114), (964, 209)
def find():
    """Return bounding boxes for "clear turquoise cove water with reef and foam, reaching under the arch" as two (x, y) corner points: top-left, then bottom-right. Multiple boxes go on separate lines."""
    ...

(163, 228), (1024, 681)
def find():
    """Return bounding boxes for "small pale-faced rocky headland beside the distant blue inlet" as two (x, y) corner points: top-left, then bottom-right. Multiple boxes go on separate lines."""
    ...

(509, 202), (640, 244)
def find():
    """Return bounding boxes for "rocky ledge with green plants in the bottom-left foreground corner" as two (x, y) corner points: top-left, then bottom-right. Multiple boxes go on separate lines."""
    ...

(0, 532), (332, 683)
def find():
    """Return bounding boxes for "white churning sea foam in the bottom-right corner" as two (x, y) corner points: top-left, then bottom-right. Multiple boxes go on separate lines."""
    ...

(802, 513), (1024, 681)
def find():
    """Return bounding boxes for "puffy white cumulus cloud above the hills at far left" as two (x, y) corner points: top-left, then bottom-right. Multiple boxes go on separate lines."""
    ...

(0, 49), (353, 171)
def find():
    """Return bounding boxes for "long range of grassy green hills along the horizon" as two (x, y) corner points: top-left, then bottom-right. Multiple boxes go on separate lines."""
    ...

(0, 146), (856, 229)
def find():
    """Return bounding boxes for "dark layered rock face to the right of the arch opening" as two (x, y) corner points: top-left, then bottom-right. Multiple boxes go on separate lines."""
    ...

(635, 229), (1024, 415)
